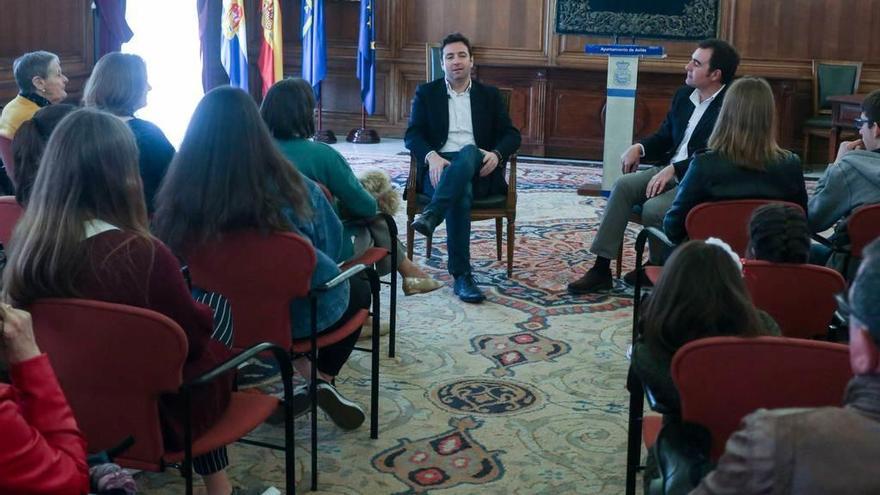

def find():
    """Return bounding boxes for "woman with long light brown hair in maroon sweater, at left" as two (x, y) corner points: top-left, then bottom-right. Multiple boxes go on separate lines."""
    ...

(4, 110), (232, 495)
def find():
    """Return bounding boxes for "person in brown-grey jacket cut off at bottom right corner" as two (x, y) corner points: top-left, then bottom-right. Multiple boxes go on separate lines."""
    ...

(691, 240), (880, 495)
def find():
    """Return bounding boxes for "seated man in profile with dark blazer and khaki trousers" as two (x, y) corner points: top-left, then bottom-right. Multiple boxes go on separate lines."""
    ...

(568, 39), (739, 294)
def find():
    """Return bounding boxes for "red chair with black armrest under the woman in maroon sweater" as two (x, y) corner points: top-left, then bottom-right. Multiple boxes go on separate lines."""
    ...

(28, 299), (294, 494)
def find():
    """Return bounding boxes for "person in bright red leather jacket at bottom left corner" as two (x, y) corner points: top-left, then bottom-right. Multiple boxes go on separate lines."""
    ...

(0, 304), (89, 495)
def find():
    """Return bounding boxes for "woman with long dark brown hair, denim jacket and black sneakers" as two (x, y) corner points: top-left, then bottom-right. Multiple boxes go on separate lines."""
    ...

(154, 86), (371, 429)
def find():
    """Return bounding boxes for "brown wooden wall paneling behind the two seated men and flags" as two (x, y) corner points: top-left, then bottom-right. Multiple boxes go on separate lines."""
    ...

(282, 0), (880, 159)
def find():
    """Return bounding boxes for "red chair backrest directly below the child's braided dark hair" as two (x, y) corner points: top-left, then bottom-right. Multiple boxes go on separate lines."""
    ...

(743, 260), (846, 339)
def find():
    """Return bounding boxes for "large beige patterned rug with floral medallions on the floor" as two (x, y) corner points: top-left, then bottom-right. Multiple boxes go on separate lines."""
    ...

(138, 154), (648, 494)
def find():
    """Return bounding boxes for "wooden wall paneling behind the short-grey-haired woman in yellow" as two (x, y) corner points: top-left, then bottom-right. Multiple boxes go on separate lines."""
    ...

(0, 0), (94, 105)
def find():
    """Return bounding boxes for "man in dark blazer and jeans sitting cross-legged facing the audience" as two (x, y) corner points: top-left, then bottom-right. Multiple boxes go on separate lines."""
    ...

(405, 33), (520, 303)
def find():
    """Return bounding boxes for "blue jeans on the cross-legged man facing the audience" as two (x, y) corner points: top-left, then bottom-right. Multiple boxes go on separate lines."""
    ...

(422, 145), (483, 277)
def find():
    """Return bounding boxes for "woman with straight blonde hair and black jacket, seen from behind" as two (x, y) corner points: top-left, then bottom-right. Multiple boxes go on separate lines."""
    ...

(663, 77), (807, 243)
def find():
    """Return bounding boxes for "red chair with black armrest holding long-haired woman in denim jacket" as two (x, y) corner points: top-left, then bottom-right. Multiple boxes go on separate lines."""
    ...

(186, 230), (379, 490)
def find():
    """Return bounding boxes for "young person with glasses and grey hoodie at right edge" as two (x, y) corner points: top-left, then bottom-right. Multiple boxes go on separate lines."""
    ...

(807, 90), (880, 279)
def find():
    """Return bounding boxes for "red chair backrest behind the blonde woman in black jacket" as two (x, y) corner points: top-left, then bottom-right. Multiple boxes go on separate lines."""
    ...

(685, 199), (803, 256)
